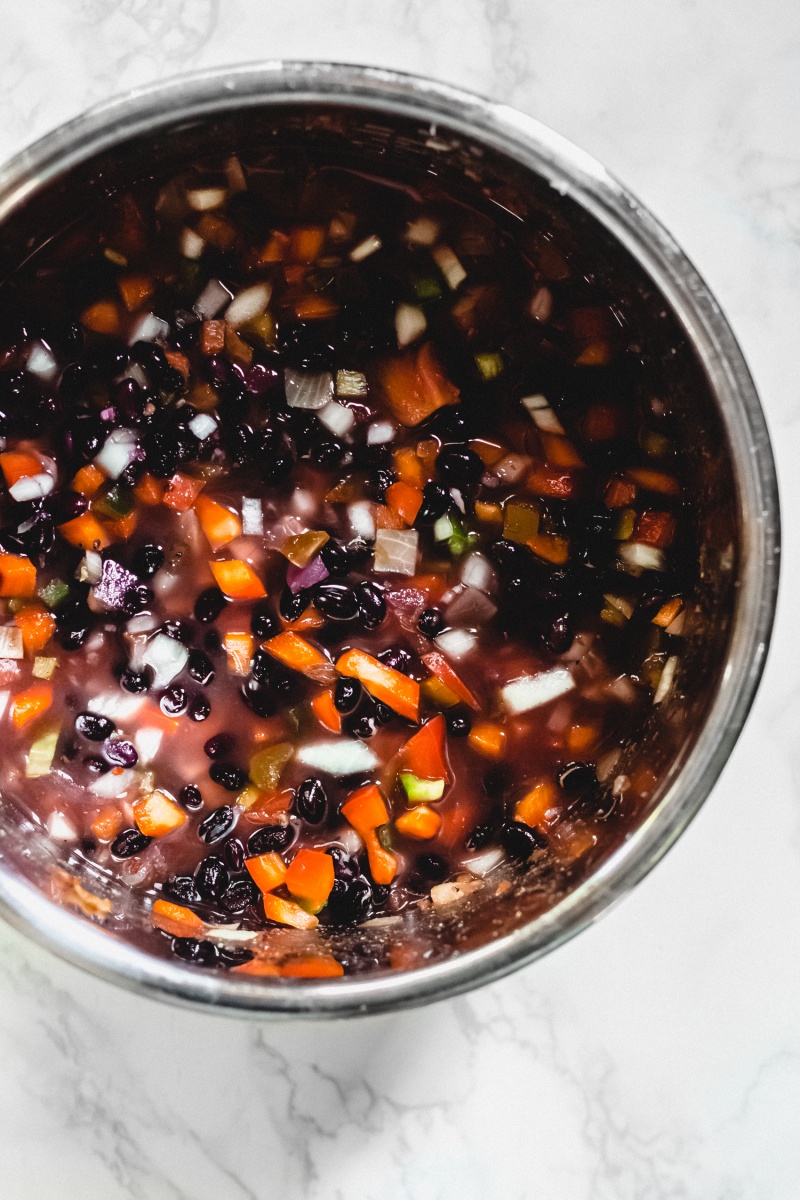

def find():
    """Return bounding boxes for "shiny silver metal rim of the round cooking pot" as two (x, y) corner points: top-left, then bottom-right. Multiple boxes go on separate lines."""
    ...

(0, 61), (780, 1016)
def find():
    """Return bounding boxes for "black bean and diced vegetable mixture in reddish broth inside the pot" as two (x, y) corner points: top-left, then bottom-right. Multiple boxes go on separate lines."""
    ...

(0, 147), (696, 977)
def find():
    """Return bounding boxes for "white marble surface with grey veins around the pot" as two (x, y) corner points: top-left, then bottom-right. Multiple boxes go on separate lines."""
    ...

(0, 0), (800, 1200)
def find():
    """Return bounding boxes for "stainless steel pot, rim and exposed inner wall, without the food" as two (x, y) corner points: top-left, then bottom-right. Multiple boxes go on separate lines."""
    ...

(0, 62), (780, 1016)
